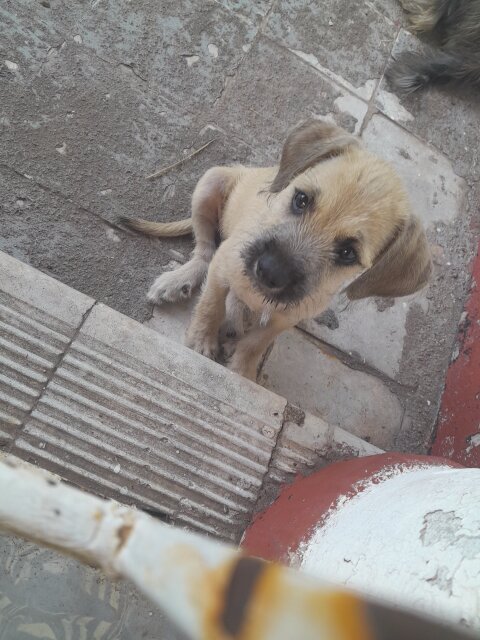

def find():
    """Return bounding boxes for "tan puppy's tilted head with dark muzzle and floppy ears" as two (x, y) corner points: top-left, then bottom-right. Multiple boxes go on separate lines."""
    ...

(243, 120), (431, 306)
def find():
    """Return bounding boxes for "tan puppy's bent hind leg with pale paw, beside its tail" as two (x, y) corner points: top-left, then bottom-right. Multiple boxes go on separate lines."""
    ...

(147, 167), (237, 304)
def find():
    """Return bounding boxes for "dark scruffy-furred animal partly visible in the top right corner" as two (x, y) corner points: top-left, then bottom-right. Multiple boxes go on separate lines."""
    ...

(387, 0), (480, 93)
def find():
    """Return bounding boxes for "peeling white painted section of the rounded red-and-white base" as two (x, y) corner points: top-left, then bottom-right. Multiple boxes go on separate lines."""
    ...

(299, 464), (480, 629)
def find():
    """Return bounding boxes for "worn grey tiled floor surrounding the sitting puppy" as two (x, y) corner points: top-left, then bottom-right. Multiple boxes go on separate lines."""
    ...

(0, 0), (480, 452)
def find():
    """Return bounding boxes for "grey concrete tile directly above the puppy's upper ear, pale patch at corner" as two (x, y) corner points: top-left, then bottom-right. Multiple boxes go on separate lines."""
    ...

(213, 38), (367, 162)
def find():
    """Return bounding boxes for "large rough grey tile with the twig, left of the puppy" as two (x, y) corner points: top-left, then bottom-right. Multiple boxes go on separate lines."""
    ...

(0, 37), (262, 230)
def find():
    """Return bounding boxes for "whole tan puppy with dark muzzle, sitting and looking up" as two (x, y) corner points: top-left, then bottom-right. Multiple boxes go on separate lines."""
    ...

(123, 120), (431, 379)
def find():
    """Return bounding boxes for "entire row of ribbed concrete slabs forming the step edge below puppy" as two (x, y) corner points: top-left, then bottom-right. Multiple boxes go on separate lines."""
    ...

(0, 253), (377, 541)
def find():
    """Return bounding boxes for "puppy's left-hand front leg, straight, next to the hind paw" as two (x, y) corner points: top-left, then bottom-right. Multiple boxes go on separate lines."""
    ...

(185, 251), (228, 360)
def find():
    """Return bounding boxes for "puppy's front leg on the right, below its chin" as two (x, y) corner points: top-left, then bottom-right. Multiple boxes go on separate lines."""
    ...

(228, 316), (295, 380)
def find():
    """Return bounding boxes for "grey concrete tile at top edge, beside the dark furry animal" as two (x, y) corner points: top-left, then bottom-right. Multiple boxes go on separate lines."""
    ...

(264, 0), (397, 99)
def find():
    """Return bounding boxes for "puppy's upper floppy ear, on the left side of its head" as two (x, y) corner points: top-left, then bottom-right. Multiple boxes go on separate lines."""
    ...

(270, 120), (360, 193)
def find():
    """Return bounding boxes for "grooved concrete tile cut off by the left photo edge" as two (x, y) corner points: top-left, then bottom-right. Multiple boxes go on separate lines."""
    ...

(0, 252), (94, 447)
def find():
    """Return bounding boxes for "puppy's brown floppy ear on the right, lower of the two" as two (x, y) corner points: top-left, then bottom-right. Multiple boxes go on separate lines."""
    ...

(345, 216), (432, 300)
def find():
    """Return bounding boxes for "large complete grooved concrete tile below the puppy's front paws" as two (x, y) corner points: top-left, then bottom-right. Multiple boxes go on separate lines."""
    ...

(15, 305), (285, 540)
